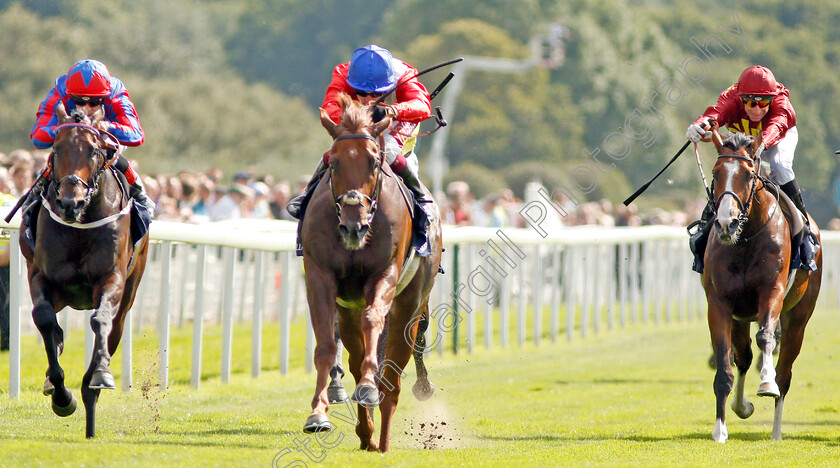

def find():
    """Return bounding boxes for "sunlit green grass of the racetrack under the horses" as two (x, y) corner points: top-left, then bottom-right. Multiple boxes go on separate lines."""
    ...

(0, 311), (840, 467)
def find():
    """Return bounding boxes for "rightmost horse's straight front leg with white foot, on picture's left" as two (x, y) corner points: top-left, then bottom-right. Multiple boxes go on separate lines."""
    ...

(707, 295), (733, 443)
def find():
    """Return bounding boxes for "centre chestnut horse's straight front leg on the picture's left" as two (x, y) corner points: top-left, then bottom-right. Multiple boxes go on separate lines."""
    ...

(303, 257), (338, 432)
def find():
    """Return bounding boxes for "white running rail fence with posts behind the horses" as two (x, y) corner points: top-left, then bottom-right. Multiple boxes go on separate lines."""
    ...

(0, 216), (840, 398)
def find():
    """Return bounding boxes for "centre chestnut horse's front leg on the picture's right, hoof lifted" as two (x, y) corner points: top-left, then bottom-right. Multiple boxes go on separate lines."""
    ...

(351, 265), (399, 408)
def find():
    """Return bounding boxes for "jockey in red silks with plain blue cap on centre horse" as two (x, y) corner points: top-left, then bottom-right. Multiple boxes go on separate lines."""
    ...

(287, 45), (433, 256)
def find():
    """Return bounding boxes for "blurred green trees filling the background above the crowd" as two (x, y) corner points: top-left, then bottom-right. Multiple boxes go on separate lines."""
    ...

(0, 0), (840, 220)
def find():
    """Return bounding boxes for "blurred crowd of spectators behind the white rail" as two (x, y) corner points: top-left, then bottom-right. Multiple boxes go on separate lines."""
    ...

(0, 149), (736, 227)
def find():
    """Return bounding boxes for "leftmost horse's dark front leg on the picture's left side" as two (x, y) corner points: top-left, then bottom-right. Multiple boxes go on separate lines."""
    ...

(29, 270), (77, 417)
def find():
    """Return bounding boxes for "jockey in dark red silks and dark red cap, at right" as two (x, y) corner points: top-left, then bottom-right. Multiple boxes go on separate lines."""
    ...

(686, 65), (818, 272)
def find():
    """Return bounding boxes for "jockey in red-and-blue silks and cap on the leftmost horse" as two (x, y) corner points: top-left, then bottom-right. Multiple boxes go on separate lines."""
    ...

(24, 59), (155, 224)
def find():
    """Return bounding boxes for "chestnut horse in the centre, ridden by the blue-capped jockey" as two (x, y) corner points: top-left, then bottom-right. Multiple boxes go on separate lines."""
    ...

(301, 95), (442, 452)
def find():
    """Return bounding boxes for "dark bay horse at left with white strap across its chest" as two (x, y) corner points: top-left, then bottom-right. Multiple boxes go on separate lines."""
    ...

(20, 103), (148, 438)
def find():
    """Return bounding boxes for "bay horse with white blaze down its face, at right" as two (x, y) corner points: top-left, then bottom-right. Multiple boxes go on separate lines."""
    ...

(702, 126), (822, 443)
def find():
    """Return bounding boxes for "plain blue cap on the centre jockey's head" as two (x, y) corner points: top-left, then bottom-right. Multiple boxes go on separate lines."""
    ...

(347, 44), (400, 93)
